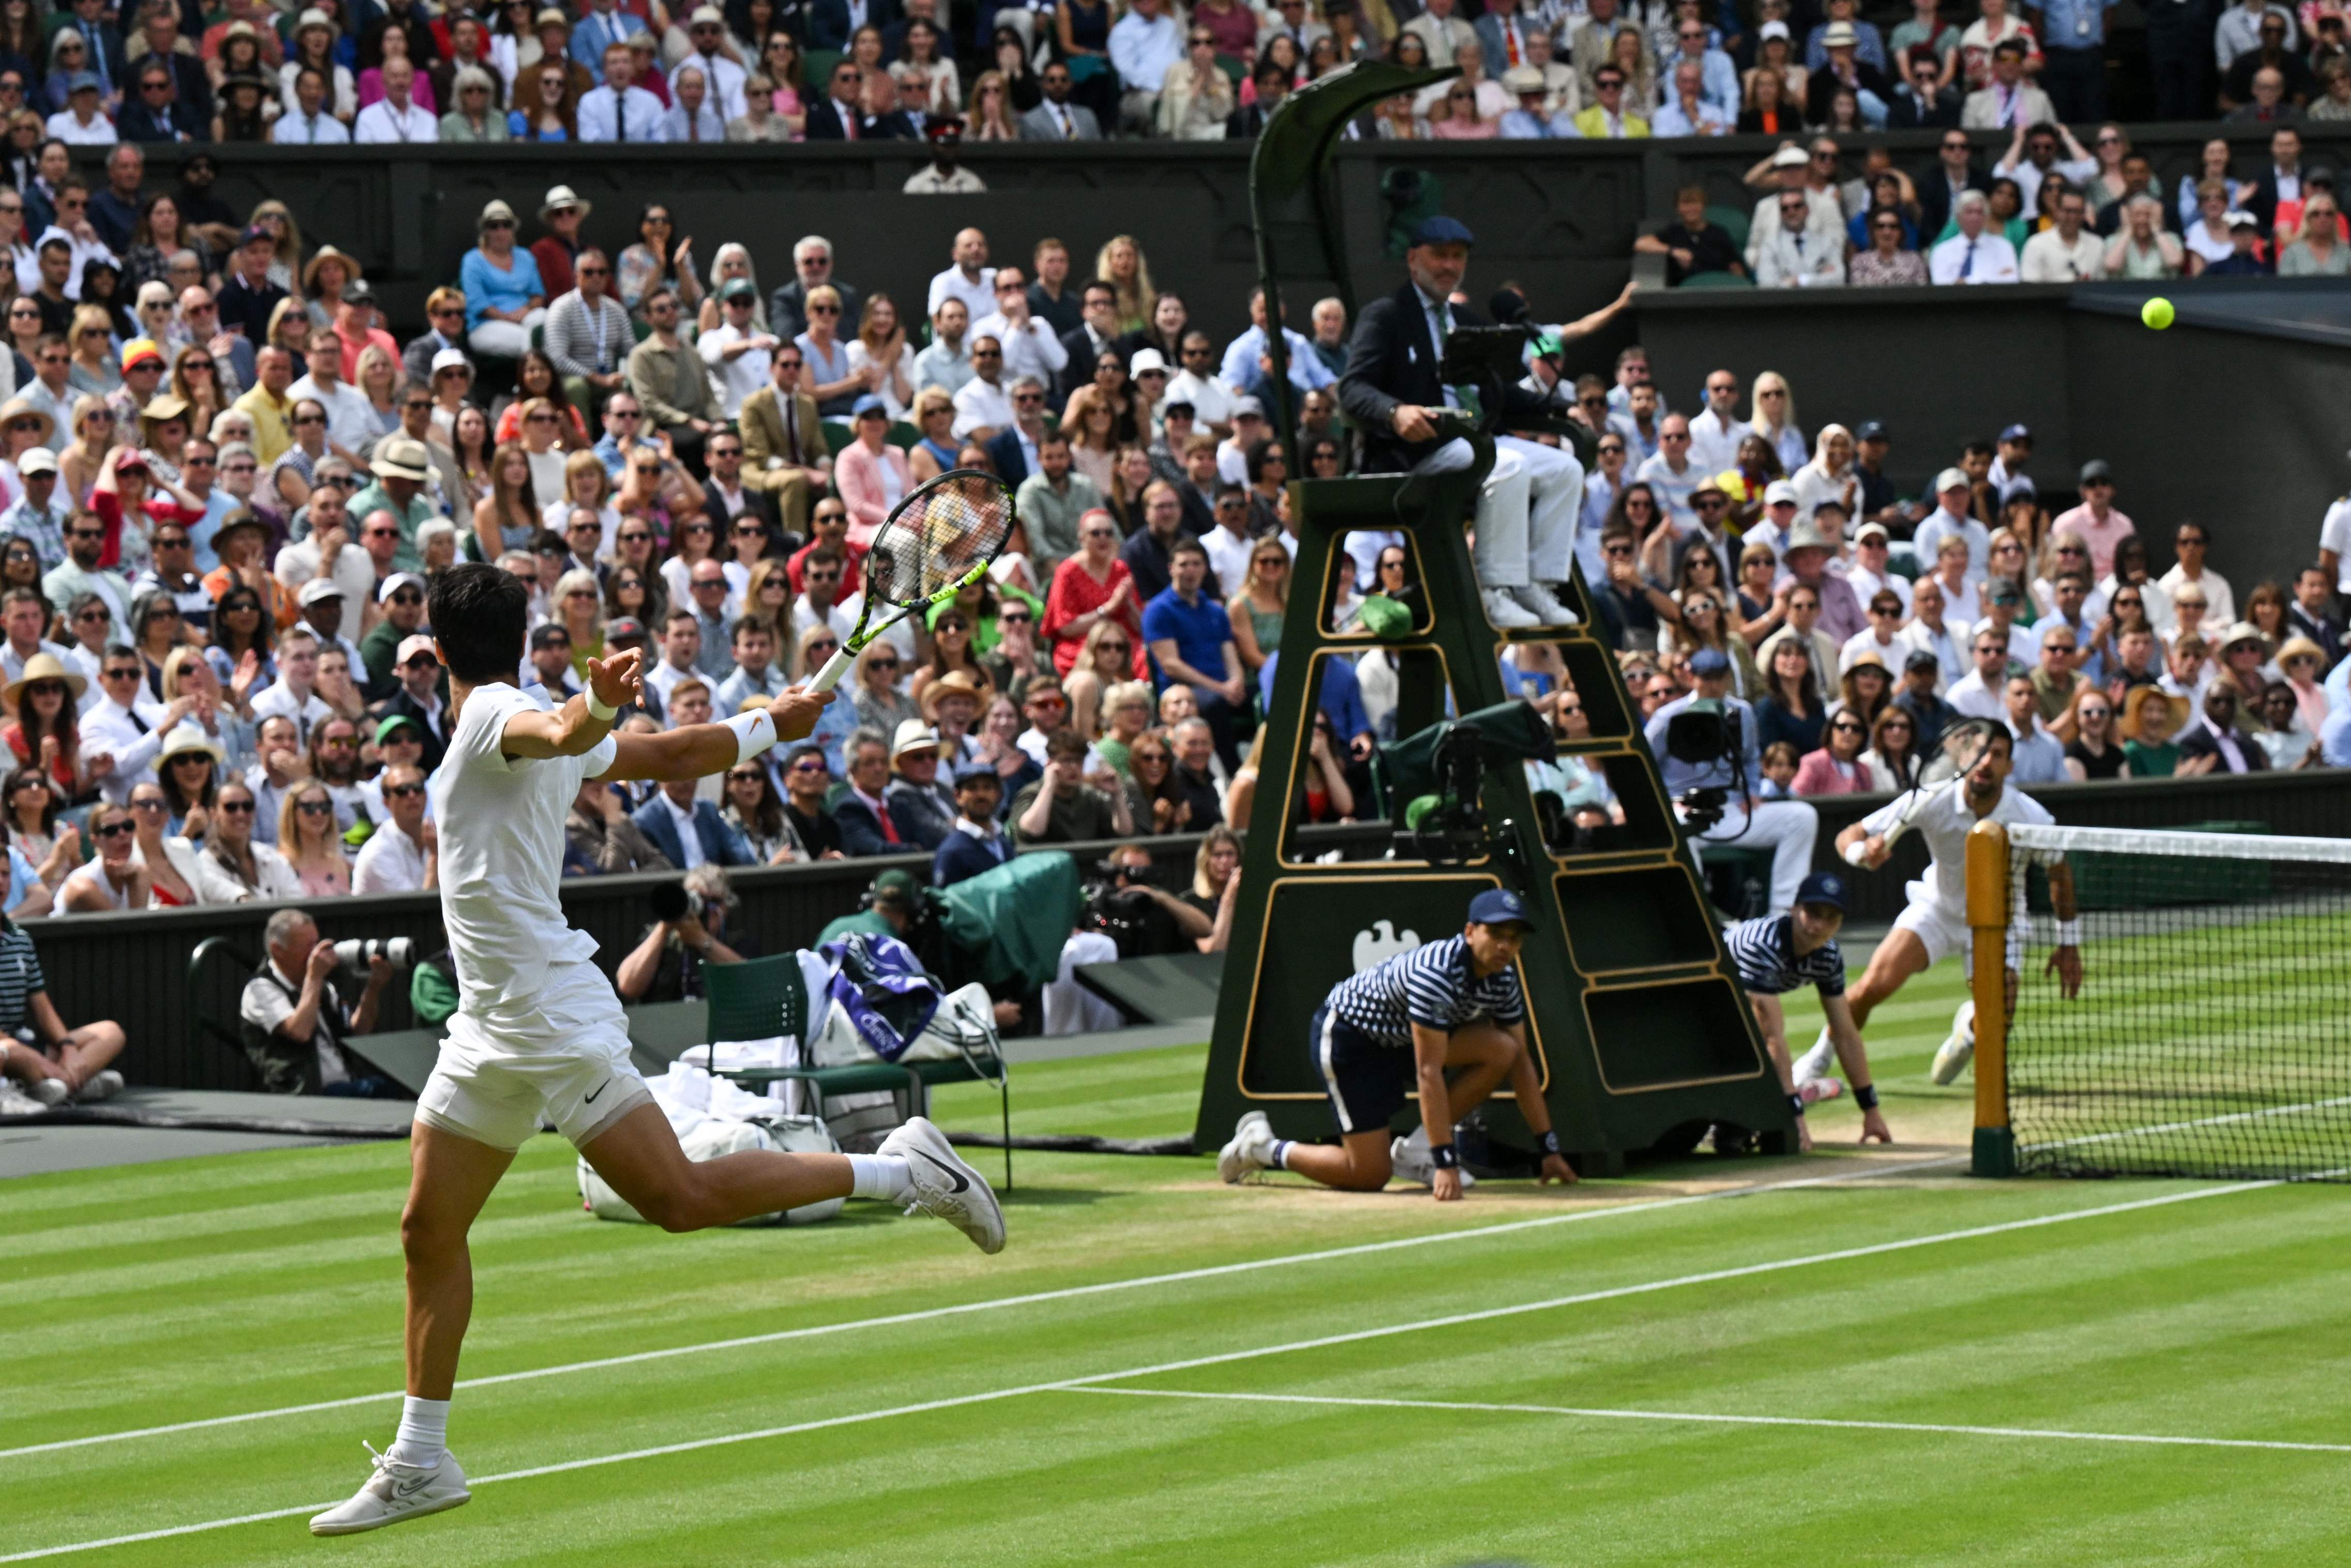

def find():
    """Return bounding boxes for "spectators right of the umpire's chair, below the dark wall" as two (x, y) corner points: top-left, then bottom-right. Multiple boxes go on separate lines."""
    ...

(1578, 348), (2351, 799)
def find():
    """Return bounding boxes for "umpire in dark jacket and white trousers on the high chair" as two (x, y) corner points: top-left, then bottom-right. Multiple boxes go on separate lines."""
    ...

(1338, 216), (1584, 628)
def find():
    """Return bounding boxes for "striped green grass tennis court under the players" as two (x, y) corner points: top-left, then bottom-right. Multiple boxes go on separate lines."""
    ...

(0, 966), (2351, 1568)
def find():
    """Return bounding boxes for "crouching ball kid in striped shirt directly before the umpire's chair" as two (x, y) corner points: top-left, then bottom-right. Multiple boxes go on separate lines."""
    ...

(1215, 889), (1575, 1204)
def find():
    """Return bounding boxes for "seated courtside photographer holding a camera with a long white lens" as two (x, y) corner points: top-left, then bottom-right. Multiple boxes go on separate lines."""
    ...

(237, 910), (402, 1100)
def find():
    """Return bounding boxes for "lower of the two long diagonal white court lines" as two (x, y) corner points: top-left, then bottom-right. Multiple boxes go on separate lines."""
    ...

(0, 1182), (2285, 1563)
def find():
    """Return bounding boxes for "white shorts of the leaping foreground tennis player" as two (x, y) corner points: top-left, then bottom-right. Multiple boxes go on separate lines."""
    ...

(416, 964), (653, 1150)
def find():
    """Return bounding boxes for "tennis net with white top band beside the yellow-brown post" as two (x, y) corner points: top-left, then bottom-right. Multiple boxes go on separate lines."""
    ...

(2005, 825), (2351, 1180)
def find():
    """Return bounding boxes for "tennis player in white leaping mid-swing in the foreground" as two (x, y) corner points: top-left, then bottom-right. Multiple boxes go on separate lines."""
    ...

(310, 564), (1004, 1535)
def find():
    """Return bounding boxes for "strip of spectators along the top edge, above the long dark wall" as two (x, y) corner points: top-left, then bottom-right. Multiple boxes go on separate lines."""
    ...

(0, 0), (2351, 153)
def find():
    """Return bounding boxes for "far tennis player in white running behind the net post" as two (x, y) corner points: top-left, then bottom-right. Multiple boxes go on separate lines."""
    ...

(1796, 726), (2081, 1088)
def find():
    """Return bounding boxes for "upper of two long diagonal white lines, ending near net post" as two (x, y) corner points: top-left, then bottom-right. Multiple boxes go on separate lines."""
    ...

(0, 1154), (1968, 1467)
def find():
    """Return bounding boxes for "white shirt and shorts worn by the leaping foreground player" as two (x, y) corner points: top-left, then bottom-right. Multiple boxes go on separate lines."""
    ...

(416, 684), (649, 1150)
